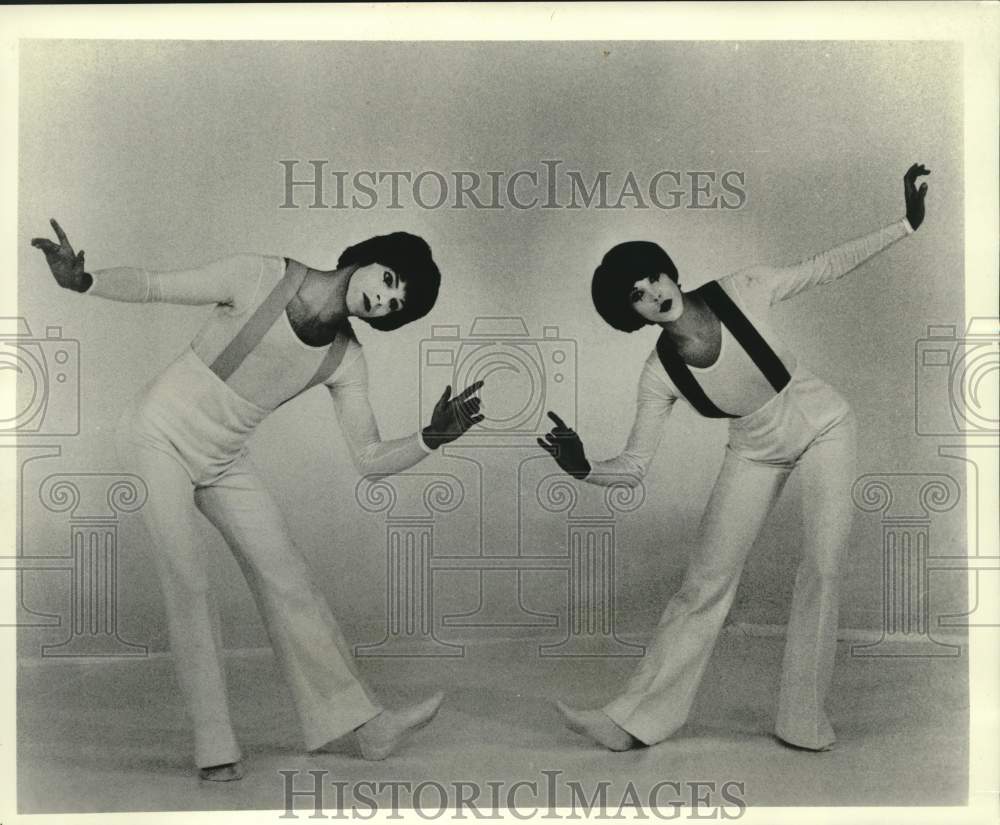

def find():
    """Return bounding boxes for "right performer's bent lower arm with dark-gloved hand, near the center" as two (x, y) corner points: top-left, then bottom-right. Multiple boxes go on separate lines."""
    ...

(538, 359), (676, 487)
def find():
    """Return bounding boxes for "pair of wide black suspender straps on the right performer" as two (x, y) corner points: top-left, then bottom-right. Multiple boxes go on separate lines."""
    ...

(656, 281), (791, 418)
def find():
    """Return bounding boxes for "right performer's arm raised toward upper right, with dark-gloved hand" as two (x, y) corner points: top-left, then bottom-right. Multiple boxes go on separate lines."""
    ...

(738, 163), (930, 304)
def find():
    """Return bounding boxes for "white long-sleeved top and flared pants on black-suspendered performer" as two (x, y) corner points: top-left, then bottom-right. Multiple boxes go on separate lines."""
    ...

(586, 220), (912, 750)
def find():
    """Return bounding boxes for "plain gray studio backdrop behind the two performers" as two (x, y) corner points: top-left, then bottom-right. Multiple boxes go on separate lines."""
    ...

(15, 41), (974, 656)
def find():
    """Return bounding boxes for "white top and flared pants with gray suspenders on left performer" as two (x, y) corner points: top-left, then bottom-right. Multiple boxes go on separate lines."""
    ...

(87, 255), (428, 767)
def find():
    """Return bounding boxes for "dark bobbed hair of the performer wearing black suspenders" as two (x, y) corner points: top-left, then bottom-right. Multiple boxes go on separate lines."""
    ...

(590, 241), (677, 332)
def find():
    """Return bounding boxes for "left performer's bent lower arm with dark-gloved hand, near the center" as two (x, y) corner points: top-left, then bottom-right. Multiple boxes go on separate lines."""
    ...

(327, 348), (483, 475)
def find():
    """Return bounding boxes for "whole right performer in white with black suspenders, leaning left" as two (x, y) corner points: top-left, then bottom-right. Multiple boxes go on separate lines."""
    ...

(539, 164), (929, 751)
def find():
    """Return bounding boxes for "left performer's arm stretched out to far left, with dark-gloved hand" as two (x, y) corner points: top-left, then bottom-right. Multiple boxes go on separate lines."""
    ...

(31, 220), (264, 306)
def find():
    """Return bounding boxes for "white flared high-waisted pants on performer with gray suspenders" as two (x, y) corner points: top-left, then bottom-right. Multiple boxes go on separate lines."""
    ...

(117, 351), (381, 767)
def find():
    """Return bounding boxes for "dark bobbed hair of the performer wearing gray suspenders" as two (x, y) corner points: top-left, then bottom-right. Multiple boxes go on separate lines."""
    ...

(337, 232), (441, 332)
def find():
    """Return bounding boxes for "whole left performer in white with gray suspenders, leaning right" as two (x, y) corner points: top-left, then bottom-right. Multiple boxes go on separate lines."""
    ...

(32, 220), (483, 781)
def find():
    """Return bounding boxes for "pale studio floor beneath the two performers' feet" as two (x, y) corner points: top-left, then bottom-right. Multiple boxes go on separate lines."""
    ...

(18, 631), (968, 816)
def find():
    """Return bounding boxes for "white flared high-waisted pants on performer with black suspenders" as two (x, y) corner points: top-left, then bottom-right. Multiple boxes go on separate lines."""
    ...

(604, 370), (855, 750)
